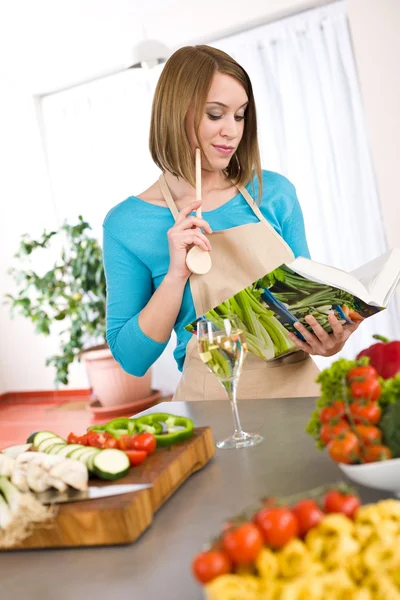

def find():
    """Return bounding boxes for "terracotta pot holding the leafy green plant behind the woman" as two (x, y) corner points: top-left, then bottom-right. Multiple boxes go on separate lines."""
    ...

(82, 346), (151, 406)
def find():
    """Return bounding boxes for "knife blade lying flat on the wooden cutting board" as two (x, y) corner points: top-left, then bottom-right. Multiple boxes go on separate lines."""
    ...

(35, 483), (153, 504)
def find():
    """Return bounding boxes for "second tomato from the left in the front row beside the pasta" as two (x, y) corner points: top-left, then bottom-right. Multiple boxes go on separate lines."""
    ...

(222, 523), (263, 565)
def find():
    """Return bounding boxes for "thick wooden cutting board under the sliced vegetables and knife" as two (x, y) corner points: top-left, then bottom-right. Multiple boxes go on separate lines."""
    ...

(7, 427), (215, 550)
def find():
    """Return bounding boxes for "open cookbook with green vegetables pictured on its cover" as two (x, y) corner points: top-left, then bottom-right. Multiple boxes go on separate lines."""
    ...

(185, 248), (400, 360)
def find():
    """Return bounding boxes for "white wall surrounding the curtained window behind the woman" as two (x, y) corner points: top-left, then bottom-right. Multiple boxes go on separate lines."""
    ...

(0, 0), (400, 392)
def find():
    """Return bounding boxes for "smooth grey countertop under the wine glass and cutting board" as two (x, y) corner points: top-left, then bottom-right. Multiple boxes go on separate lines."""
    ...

(0, 398), (384, 600)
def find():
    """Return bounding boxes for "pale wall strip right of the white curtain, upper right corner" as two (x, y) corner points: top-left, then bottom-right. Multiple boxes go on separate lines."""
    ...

(349, 0), (400, 247)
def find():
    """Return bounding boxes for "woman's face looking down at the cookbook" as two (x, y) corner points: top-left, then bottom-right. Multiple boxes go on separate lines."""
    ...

(186, 73), (248, 171)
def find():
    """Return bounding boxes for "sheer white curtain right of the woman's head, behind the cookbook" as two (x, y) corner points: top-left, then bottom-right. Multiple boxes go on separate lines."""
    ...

(213, 1), (400, 368)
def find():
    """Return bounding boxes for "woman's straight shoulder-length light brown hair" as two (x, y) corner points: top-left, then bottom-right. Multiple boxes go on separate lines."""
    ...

(149, 46), (262, 199)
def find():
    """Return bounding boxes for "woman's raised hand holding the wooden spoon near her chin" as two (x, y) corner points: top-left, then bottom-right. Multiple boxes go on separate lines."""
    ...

(168, 202), (212, 281)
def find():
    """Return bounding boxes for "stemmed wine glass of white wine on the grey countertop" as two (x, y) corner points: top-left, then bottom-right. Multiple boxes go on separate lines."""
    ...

(197, 317), (263, 448)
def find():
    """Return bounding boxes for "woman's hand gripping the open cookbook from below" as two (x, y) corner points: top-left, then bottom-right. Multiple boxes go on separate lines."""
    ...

(289, 313), (360, 356)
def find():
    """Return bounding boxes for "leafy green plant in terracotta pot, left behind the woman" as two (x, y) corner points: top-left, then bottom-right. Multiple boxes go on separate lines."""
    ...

(6, 216), (151, 406)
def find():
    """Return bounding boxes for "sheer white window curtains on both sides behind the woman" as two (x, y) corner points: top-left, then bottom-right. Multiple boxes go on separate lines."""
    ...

(42, 2), (400, 392)
